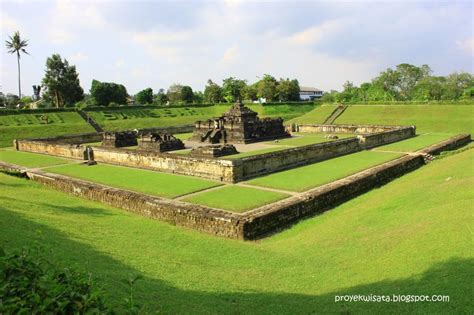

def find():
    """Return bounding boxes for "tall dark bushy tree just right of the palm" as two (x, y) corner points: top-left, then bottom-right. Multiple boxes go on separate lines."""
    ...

(42, 54), (84, 107)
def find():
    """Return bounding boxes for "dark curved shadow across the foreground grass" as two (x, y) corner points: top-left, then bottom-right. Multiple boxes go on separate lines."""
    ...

(0, 207), (474, 314)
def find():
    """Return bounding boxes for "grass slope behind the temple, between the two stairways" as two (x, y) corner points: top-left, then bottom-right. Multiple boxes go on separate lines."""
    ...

(88, 104), (314, 130)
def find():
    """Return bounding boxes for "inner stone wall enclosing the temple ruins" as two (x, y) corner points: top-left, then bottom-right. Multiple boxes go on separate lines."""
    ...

(15, 125), (416, 183)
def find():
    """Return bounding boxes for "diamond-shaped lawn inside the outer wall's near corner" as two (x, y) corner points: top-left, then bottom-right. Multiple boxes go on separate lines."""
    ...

(183, 185), (289, 212)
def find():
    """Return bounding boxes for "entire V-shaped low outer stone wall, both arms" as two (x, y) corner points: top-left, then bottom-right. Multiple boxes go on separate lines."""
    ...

(0, 135), (470, 240)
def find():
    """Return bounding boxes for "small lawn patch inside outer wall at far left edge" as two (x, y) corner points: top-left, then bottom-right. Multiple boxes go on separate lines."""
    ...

(0, 149), (71, 167)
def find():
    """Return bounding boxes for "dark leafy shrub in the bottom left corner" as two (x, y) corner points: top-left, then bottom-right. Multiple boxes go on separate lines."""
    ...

(0, 248), (112, 314)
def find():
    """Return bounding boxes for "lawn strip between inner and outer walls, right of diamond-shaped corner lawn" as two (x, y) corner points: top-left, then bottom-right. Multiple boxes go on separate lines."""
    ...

(246, 151), (402, 191)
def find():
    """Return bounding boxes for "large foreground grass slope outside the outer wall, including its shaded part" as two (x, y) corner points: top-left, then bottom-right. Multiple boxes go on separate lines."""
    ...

(0, 150), (474, 314)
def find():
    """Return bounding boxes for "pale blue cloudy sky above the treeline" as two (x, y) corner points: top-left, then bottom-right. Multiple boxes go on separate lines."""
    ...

(0, 0), (474, 95)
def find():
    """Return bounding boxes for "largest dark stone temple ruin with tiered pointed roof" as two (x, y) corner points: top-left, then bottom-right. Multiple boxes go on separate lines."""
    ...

(191, 102), (290, 143)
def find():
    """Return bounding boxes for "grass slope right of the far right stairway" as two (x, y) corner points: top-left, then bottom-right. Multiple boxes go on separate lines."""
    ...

(334, 105), (474, 134)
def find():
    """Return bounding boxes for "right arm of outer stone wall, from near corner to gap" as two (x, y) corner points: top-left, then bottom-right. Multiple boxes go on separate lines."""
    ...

(243, 156), (424, 239)
